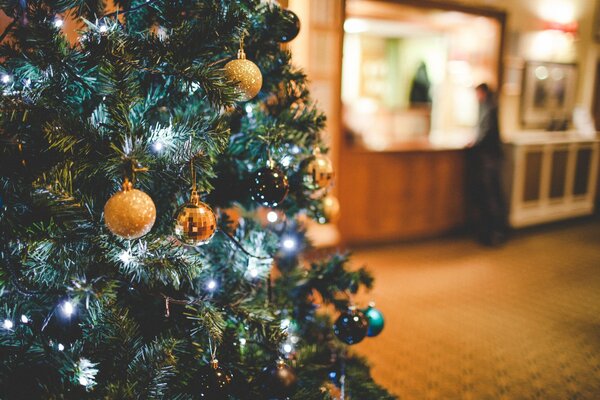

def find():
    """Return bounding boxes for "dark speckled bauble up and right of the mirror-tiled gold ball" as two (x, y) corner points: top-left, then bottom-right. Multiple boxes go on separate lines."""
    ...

(250, 164), (290, 207)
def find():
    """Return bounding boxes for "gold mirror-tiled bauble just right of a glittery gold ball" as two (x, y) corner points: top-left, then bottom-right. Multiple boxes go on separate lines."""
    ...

(175, 191), (217, 246)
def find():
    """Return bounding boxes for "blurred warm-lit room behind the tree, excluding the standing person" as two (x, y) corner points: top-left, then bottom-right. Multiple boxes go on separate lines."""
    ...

(282, 0), (600, 399)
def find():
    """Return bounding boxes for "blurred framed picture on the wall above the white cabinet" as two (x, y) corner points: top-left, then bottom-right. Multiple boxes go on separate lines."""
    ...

(521, 61), (577, 130)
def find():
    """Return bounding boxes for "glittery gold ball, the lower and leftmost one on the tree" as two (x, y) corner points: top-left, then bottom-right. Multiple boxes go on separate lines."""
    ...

(104, 178), (156, 240)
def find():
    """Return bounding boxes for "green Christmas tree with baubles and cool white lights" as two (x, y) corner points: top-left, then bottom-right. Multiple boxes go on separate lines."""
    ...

(0, 0), (392, 400)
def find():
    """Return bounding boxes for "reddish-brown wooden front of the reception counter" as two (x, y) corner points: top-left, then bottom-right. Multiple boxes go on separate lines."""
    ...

(338, 143), (466, 244)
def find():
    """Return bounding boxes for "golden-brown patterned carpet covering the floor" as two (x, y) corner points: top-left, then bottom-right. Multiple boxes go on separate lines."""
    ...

(353, 218), (600, 400)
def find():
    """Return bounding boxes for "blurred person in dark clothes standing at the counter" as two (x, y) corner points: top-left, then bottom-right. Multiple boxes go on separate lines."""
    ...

(467, 83), (508, 246)
